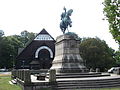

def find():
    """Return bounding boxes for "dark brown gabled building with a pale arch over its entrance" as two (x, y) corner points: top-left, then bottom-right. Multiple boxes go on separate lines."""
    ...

(15, 29), (55, 69)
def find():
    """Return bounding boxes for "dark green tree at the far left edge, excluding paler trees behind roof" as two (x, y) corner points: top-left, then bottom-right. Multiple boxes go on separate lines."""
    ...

(0, 36), (22, 68)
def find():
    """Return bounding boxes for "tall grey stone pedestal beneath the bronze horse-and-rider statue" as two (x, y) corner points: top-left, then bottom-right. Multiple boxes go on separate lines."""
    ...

(51, 35), (86, 73)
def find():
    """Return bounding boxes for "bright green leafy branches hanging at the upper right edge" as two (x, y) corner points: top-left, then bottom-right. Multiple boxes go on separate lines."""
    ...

(103, 0), (120, 46)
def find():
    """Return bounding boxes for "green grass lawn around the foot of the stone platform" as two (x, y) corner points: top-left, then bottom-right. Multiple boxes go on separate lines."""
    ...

(0, 73), (120, 90)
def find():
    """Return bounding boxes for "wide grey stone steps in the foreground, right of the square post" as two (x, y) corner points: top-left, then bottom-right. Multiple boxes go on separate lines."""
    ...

(57, 78), (120, 90)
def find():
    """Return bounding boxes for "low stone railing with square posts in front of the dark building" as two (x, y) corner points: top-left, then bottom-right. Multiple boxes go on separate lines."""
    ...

(11, 69), (56, 84)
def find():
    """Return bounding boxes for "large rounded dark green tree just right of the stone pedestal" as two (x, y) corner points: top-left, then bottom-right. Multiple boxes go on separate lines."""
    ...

(80, 38), (115, 71)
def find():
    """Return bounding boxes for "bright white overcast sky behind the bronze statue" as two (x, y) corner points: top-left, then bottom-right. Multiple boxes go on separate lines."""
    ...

(0, 0), (118, 50)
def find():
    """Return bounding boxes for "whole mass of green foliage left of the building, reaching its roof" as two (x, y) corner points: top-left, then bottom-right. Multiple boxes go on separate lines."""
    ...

(0, 32), (35, 68)
